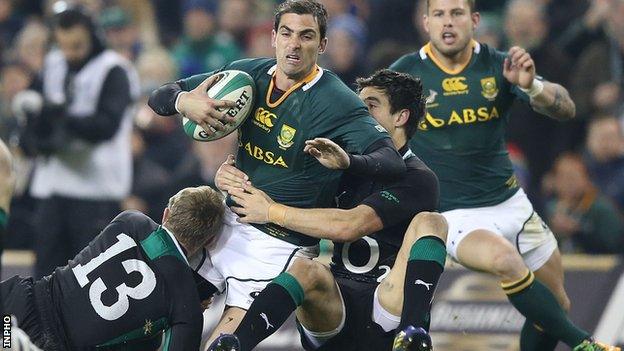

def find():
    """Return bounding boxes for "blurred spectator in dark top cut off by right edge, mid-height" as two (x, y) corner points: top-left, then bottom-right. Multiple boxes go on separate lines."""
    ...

(585, 116), (624, 209)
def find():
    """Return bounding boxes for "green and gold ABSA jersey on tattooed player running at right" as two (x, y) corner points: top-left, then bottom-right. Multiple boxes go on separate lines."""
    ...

(390, 41), (528, 211)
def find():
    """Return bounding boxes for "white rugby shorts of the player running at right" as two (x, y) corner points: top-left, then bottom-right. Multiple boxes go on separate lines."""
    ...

(442, 189), (557, 271)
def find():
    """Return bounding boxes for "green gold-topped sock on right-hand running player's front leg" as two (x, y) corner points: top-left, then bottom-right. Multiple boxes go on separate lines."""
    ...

(501, 272), (590, 351)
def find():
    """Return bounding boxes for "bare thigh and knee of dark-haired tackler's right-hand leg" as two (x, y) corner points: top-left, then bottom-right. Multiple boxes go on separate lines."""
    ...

(376, 212), (448, 316)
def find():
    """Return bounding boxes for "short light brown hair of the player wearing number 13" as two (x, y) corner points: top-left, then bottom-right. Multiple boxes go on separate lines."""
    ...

(163, 186), (225, 250)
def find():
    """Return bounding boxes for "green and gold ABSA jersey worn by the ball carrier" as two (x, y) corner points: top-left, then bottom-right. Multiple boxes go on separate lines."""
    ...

(179, 58), (389, 245)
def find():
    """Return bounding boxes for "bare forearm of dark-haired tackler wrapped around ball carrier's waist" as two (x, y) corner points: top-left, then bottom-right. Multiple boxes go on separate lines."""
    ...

(269, 205), (370, 241)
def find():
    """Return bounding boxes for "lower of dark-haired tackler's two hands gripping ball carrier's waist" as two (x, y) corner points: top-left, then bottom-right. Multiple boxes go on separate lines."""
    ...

(229, 183), (275, 224)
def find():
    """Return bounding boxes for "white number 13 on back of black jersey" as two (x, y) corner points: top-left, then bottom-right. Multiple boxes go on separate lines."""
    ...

(72, 233), (156, 321)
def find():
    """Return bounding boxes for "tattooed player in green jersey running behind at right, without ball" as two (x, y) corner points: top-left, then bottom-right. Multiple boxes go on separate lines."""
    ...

(391, 0), (619, 351)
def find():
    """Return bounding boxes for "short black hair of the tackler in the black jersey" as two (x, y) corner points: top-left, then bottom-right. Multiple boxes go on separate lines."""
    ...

(356, 69), (425, 139)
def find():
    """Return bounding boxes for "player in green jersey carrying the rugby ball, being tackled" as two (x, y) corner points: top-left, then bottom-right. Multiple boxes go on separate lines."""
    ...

(149, 0), (405, 337)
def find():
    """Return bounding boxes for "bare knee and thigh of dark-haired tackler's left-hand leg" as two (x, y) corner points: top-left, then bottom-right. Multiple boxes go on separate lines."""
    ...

(288, 258), (345, 333)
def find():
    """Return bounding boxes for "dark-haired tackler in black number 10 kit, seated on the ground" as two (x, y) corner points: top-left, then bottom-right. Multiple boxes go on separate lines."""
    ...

(213, 70), (447, 351)
